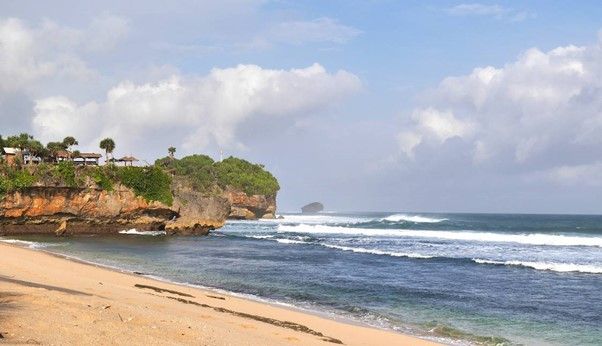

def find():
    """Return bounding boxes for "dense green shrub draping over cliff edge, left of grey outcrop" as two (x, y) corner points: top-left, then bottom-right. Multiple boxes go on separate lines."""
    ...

(117, 166), (173, 205)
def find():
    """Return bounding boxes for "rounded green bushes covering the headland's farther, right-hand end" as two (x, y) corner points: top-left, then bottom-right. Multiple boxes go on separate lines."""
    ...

(155, 155), (280, 196)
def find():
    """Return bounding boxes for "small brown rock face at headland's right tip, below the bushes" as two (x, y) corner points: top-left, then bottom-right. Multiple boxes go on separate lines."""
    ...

(225, 189), (276, 220)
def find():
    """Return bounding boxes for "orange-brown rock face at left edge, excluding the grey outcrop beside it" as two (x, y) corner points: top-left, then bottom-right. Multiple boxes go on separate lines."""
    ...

(0, 185), (178, 235)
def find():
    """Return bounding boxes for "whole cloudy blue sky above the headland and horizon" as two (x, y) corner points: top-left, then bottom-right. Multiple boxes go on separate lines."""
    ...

(0, 0), (602, 214)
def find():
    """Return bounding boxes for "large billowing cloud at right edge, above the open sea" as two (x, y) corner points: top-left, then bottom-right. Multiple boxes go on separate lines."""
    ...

(398, 34), (602, 185)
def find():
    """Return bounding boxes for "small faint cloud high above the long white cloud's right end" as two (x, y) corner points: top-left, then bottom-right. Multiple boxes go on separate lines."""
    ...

(266, 17), (362, 44)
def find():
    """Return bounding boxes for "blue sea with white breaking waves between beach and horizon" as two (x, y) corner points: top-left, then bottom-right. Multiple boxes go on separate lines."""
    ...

(1, 212), (602, 345)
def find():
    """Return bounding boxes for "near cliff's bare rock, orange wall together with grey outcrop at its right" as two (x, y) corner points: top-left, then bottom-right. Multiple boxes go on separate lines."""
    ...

(0, 181), (230, 235)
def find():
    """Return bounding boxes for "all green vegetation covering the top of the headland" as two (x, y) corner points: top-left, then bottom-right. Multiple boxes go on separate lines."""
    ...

(0, 133), (280, 205)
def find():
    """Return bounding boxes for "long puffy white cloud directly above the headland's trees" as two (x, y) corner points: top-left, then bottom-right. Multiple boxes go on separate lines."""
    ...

(33, 64), (360, 157)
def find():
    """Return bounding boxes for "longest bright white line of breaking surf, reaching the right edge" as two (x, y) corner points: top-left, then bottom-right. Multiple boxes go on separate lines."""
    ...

(277, 224), (602, 247)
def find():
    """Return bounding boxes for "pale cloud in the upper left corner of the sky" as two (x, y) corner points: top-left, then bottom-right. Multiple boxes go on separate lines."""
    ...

(0, 15), (127, 94)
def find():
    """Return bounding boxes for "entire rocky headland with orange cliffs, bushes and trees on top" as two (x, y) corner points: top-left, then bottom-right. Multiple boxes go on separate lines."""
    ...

(0, 132), (279, 235)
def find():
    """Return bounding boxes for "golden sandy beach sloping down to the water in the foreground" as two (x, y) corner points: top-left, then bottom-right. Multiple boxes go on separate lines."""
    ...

(0, 244), (433, 345)
